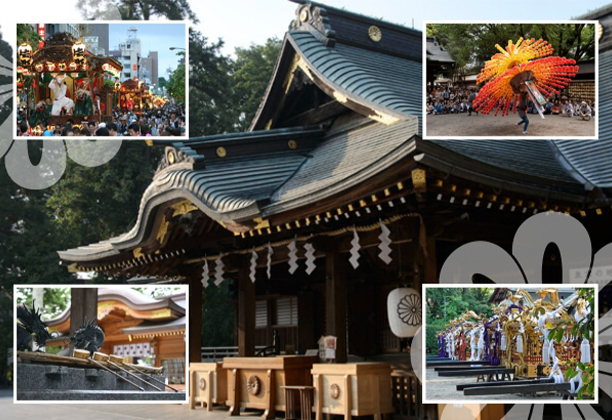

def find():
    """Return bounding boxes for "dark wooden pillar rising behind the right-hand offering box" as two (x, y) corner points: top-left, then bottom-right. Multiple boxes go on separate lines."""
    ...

(325, 244), (348, 363)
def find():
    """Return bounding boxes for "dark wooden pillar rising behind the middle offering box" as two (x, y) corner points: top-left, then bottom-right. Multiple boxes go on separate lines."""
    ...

(238, 260), (255, 357)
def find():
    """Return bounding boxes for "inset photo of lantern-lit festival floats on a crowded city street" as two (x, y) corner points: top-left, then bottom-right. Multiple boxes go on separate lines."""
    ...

(13, 21), (189, 139)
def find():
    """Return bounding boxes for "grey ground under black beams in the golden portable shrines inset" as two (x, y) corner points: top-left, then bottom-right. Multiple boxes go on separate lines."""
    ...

(425, 368), (561, 402)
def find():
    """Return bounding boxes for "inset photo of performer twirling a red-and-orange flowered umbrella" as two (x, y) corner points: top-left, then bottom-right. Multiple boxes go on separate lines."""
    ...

(423, 20), (601, 140)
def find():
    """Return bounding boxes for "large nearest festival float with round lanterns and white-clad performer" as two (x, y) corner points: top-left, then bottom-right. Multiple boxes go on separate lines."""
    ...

(17, 32), (123, 129)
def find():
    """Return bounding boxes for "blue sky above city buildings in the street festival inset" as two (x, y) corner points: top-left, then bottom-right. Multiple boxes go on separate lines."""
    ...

(108, 23), (186, 79)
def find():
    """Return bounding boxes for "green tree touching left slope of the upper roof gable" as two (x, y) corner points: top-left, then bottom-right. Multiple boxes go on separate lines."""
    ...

(233, 38), (282, 131)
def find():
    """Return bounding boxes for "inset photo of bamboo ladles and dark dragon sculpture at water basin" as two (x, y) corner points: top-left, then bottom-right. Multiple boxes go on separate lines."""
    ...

(13, 285), (189, 404)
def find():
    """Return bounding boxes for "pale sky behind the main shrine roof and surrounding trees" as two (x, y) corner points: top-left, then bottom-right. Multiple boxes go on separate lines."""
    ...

(0, 0), (612, 55)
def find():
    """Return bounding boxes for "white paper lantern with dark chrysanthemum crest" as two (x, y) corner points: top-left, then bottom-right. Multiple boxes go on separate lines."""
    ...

(387, 287), (423, 338)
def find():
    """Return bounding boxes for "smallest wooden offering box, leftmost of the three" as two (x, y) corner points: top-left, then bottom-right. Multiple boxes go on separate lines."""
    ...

(189, 362), (227, 411)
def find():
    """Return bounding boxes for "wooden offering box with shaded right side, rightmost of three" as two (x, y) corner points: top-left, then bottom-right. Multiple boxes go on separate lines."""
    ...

(312, 363), (393, 420)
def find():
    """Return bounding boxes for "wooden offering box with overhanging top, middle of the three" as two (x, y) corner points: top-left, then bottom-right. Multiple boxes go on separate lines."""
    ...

(223, 356), (317, 419)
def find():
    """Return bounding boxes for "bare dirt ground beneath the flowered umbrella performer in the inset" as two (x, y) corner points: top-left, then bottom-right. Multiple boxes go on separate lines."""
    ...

(425, 112), (595, 139)
